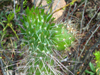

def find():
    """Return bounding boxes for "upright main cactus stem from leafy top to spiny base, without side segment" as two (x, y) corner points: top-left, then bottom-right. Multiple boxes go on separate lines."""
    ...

(21, 7), (54, 75)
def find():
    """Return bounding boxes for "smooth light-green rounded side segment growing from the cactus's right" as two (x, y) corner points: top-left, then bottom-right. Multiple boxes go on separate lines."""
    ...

(53, 24), (75, 50)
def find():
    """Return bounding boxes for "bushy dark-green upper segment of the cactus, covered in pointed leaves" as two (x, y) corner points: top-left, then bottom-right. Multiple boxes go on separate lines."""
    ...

(21, 7), (54, 50)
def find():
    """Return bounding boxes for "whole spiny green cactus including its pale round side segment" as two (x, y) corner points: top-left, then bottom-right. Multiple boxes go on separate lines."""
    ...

(20, 7), (75, 75)
